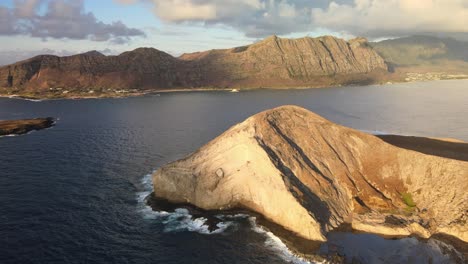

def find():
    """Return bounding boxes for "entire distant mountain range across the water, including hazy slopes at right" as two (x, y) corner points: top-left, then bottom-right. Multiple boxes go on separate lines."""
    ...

(0, 36), (468, 97)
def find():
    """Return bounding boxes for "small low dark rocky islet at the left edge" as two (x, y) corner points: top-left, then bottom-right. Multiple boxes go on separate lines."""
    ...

(0, 117), (55, 136)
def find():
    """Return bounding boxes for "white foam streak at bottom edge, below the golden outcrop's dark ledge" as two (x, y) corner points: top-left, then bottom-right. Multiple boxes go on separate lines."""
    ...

(249, 216), (322, 264)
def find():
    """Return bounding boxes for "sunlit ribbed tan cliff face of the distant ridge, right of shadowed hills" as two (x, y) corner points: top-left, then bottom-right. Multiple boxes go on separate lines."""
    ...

(180, 36), (387, 87)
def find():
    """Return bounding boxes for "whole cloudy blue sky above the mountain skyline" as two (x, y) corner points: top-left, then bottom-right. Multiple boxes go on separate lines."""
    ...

(0, 0), (468, 65)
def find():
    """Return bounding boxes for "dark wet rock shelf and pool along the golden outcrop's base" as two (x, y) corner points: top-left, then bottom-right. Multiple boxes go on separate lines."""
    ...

(146, 193), (468, 264)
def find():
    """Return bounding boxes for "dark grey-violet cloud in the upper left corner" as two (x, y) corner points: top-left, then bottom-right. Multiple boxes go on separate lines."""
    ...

(0, 0), (145, 43)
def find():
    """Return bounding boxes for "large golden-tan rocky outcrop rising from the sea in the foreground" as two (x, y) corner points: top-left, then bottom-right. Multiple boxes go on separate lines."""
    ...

(153, 106), (468, 242)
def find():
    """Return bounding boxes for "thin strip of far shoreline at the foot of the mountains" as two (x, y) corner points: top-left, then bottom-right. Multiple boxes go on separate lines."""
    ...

(0, 78), (468, 102)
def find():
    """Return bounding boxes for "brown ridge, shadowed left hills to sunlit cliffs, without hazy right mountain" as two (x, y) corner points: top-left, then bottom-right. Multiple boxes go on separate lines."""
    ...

(0, 36), (387, 94)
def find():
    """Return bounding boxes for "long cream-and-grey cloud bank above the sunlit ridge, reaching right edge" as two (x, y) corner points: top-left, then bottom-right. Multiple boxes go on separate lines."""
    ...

(115, 0), (468, 38)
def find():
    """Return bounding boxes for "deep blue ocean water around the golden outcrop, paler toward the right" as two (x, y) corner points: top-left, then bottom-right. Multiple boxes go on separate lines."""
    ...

(0, 80), (468, 264)
